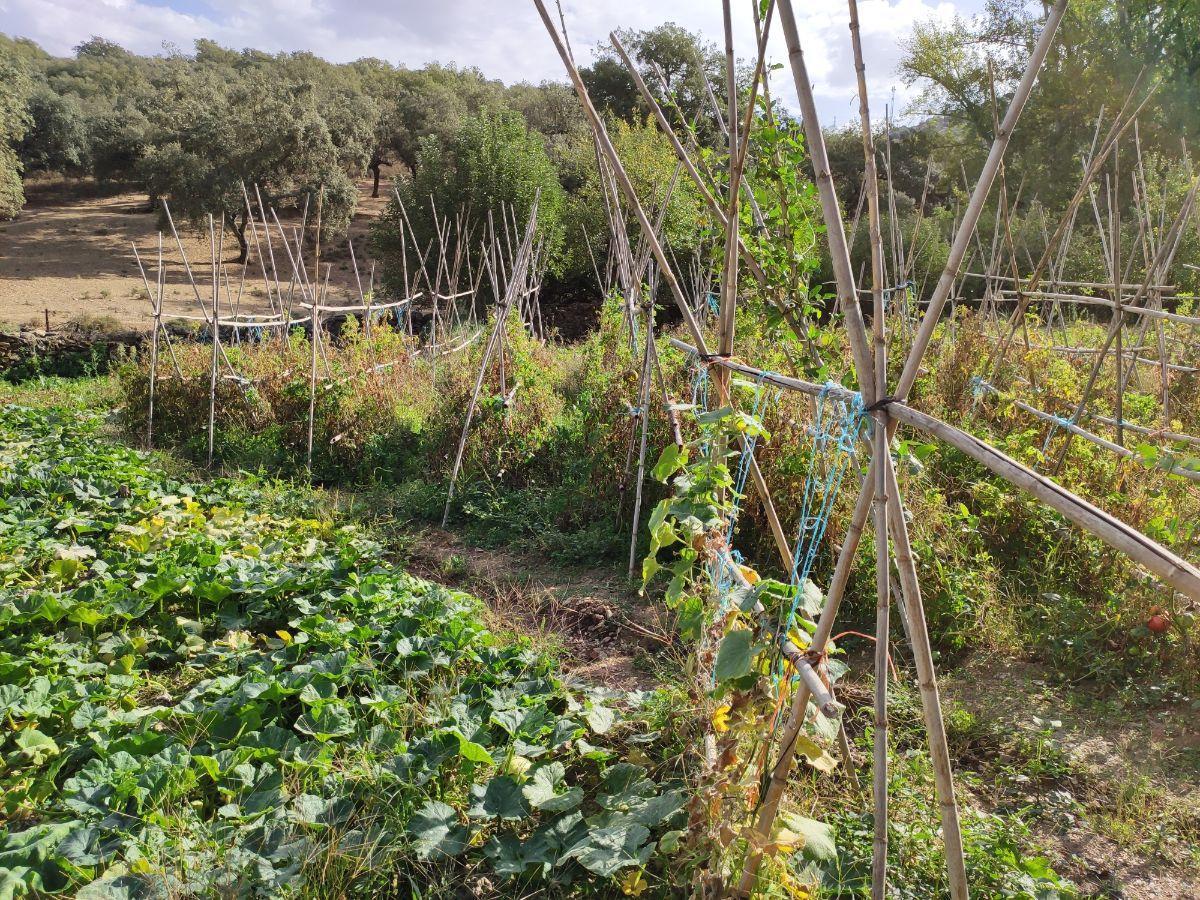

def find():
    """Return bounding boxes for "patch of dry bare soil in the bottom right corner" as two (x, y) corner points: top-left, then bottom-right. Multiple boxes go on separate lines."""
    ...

(942, 654), (1200, 900)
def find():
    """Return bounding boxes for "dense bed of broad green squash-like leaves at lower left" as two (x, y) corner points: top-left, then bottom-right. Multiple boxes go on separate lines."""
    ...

(0, 407), (685, 898)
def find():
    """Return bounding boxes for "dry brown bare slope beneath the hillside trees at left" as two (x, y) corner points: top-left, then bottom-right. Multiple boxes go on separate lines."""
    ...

(0, 180), (386, 328)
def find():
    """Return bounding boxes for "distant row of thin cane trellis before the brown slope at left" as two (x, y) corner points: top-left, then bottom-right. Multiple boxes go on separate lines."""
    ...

(132, 187), (545, 482)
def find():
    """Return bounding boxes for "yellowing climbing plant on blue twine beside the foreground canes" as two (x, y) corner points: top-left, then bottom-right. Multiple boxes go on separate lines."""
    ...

(642, 393), (845, 890)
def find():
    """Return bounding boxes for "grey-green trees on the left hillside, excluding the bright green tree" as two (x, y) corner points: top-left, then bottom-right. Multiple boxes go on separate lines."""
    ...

(0, 35), (595, 252)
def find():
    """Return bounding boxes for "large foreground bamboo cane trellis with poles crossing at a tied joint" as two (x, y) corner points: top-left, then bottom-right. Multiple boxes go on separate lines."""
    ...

(534, 0), (1200, 900)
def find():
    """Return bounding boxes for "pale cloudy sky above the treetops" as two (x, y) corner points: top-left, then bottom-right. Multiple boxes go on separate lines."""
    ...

(0, 0), (982, 125)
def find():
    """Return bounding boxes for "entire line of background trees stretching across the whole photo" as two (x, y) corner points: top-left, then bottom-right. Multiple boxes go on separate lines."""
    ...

(0, 0), (1200, 301)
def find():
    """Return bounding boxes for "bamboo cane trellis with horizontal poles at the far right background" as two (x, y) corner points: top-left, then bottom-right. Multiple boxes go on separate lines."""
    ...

(936, 81), (1200, 480)
